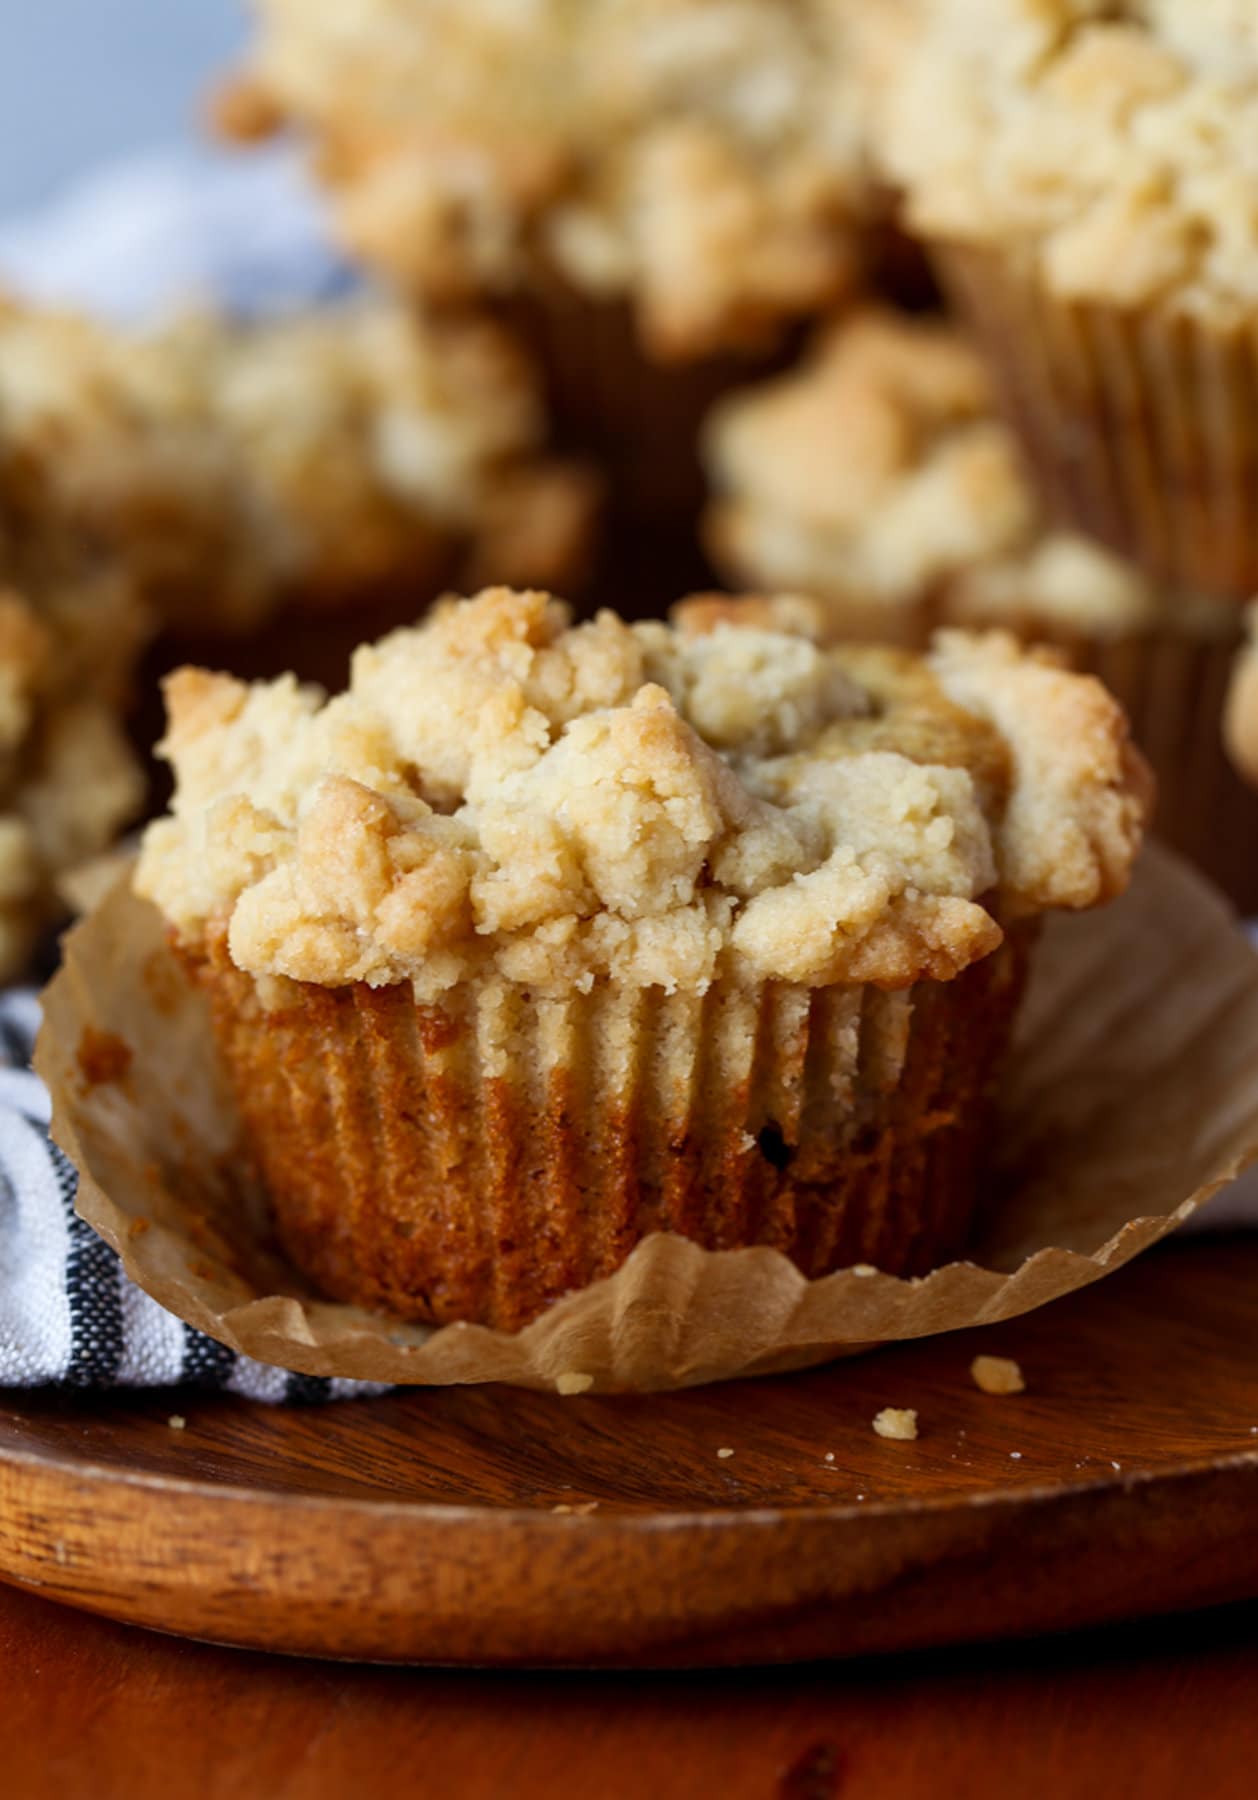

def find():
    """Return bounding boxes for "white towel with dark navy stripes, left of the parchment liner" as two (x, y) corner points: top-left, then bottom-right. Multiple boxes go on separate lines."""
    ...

(0, 988), (385, 1402)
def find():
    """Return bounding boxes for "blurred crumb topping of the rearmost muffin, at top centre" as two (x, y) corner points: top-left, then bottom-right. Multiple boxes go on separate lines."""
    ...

(229, 0), (903, 358)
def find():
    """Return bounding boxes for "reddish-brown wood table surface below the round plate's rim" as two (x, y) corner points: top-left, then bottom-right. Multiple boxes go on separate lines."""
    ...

(0, 1588), (1258, 1800)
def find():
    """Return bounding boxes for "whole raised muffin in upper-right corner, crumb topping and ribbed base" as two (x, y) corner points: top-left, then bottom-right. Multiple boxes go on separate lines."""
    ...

(878, 0), (1258, 599)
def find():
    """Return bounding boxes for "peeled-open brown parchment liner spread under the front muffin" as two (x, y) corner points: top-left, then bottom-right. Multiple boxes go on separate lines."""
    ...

(36, 846), (1258, 1391)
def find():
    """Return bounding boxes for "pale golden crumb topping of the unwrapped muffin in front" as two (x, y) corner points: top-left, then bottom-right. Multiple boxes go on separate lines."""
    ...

(137, 589), (1145, 1003)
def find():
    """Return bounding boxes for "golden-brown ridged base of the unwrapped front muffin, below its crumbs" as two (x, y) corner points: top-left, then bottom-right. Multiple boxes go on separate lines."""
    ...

(189, 925), (1033, 1330)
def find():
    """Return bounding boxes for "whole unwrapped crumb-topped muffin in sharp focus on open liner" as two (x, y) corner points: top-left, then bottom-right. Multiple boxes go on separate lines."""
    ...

(137, 590), (1145, 1328)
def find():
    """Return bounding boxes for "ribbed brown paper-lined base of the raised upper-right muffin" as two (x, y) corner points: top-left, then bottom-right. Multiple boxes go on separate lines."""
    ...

(934, 243), (1258, 601)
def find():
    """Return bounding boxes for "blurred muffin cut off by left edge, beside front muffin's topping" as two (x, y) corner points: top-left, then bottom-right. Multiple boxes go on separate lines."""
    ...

(0, 589), (144, 981)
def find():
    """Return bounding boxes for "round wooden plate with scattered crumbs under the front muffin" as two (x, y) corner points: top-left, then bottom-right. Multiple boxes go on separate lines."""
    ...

(0, 1238), (1258, 1665)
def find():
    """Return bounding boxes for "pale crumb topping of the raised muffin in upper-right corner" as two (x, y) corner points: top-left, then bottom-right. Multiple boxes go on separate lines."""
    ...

(878, 0), (1258, 319)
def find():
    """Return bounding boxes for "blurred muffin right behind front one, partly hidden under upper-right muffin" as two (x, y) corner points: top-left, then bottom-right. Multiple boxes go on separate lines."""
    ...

(705, 311), (1258, 907)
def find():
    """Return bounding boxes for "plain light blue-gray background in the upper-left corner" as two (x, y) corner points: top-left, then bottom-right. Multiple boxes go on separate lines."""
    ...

(0, 0), (247, 216)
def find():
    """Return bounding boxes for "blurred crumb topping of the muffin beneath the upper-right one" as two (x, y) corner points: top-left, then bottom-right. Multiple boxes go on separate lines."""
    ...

(705, 308), (1231, 637)
